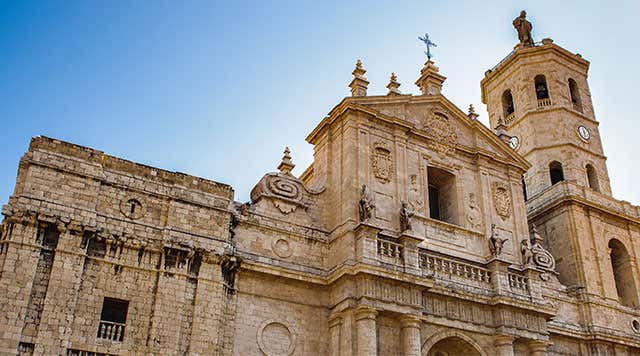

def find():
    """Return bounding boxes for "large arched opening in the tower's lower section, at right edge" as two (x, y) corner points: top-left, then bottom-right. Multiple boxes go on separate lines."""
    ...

(609, 239), (638, 308)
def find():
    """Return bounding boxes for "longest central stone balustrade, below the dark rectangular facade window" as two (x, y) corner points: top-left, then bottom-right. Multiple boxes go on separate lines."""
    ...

(420, 253), (491, 286)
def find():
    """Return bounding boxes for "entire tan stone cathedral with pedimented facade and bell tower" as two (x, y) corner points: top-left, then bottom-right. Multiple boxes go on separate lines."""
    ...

(0, 12), (640, 356)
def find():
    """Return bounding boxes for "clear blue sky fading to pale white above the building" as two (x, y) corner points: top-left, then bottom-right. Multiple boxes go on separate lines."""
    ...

(0, 0), (640, 204)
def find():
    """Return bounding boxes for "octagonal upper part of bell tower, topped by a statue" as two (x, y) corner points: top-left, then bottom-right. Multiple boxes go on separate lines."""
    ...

(481, 11), (611, 197)
